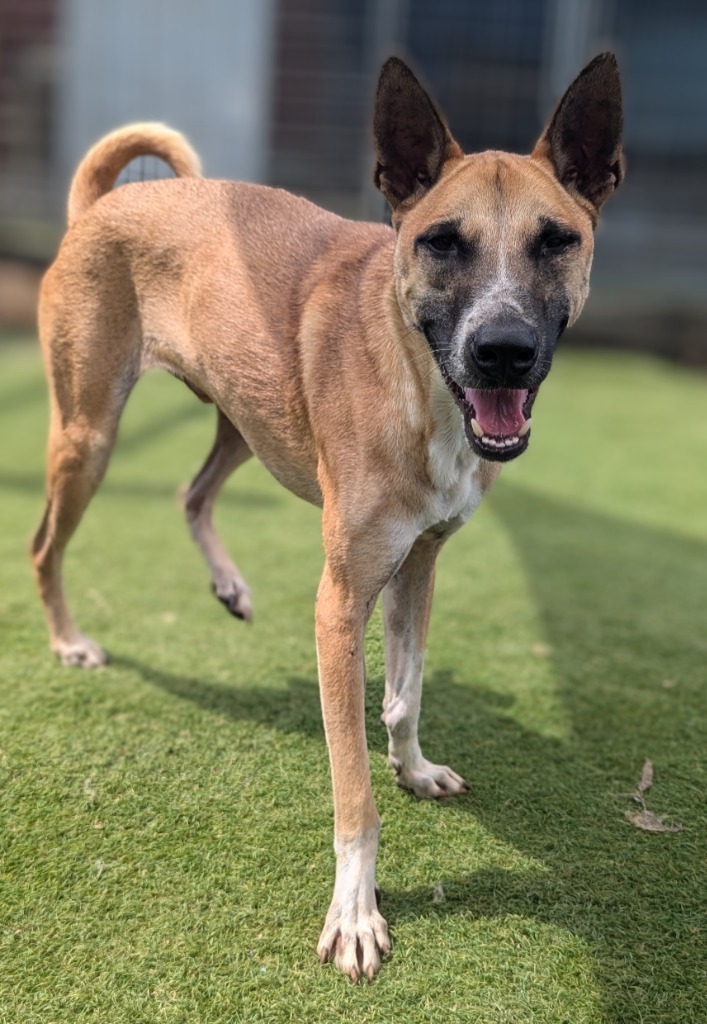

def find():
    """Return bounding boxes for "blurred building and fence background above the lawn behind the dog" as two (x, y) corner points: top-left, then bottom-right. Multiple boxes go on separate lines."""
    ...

(0, 0), (707, 364)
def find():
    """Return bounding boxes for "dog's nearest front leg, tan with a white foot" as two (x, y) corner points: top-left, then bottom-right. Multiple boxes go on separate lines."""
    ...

(317, 561), (390, 981)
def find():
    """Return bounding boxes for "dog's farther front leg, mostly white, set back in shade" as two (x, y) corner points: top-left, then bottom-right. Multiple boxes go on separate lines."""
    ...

(381, 536), (468, 799)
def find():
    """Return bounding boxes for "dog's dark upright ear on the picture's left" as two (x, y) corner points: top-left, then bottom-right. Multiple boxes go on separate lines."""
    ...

(373, 57), (463, 211)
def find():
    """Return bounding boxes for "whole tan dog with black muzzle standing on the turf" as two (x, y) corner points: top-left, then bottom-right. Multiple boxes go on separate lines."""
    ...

(34, 54), (622, 980)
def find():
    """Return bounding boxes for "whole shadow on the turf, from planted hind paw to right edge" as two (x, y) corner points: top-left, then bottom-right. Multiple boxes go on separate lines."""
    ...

(123, 483), (707, 1020)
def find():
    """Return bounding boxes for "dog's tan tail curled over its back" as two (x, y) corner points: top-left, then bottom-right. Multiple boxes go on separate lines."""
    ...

(69, 123), (201, 227)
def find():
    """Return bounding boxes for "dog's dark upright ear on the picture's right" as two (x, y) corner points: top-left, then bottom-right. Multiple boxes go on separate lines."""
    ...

(533, 53), (623, 211)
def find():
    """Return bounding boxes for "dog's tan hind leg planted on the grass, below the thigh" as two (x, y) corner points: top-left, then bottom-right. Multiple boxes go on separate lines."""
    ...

(32, 374), (133, 668)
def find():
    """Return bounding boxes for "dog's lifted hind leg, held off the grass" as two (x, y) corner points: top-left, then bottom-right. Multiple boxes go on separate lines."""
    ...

(184, 410), (252, 621)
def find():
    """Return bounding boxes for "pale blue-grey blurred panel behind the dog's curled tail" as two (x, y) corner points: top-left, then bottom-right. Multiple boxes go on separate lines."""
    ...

(54, 0), (276, 199)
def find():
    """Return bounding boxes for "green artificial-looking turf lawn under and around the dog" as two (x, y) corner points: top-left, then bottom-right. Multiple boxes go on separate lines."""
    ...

(0, 343), (707, 1024)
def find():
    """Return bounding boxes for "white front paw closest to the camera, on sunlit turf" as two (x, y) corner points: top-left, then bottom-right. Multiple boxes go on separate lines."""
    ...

(317, 893), (390, 984)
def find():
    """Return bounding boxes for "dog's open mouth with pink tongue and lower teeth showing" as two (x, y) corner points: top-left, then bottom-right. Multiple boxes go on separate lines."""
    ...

(445, 374), (538, 462)
